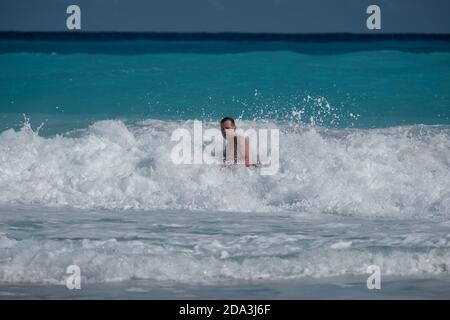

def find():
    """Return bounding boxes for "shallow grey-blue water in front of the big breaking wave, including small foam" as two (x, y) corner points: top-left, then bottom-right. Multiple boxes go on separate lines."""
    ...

(0, 206), (450, 299)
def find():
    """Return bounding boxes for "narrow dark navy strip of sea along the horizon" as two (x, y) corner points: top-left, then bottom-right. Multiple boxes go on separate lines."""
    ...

(0, 31), (450, 42)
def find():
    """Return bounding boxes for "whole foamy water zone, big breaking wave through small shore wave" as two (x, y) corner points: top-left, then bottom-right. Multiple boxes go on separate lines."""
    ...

(0, 120), (450, 284)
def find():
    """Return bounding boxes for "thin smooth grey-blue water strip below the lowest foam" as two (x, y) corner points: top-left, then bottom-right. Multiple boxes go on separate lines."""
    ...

(0, 277), (450, 300)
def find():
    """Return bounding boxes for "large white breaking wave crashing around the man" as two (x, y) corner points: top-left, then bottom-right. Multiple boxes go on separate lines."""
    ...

(0, 120), (450, 217)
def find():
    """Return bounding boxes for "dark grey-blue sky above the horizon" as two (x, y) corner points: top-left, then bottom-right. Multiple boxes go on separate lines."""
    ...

(0, 0), (450, 33)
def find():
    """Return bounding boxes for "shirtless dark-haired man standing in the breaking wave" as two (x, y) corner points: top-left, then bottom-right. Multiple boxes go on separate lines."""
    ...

(220, 117), (255, 167)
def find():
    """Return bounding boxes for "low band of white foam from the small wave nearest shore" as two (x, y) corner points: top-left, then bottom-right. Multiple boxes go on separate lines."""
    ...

(0, 232), (450, 284)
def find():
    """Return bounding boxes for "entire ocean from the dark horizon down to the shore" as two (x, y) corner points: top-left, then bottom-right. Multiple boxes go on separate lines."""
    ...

(0, 35), (450, 299)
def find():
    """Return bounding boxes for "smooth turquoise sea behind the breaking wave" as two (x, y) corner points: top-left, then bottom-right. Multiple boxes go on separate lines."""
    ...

(0, 40), (450, 131)
